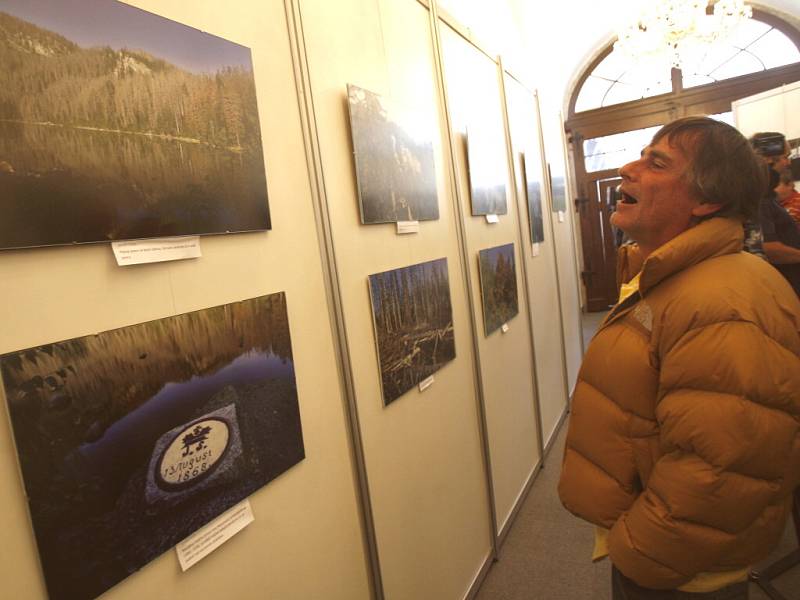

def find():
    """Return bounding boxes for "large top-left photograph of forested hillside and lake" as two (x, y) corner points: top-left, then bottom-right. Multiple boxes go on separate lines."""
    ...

(0, 0), (270, 249)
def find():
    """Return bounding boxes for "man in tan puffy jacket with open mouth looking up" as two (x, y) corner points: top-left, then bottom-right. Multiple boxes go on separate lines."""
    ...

(558, 117), (800, 600)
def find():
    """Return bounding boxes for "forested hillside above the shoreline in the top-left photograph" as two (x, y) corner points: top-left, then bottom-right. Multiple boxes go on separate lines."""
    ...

(0, 12), (261, 151)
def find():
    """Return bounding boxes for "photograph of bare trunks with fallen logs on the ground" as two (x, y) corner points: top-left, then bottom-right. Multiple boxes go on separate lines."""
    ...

(369, 258), (456, 405)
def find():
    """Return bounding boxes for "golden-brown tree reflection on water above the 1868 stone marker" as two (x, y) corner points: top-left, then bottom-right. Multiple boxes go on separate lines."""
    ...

(0, 293), (294, 504)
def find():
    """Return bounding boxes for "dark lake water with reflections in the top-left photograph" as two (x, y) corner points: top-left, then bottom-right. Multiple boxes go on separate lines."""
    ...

(0, 122), (270, 249)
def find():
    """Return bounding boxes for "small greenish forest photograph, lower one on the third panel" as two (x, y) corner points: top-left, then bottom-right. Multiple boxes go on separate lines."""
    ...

(478, 244), (519, 336)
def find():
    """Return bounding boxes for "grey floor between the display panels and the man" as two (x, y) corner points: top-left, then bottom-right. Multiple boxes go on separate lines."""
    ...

(476, 313), (800, 600)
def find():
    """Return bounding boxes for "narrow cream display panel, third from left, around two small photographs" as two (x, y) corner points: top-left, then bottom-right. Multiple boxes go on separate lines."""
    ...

(441, 26), (540, 535)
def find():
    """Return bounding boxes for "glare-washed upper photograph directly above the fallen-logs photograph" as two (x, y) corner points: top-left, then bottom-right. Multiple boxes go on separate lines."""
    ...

(347, 85), (439, 224)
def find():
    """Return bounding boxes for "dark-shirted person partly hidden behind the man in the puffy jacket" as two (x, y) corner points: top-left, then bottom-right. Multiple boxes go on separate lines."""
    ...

(750, 131), (800, 296)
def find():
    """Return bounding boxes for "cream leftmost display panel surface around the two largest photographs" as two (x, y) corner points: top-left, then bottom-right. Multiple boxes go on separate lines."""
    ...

(0, 0), (370, 600)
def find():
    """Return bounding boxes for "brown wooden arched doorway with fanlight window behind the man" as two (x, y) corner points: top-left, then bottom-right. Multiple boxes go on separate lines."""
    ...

(566, 10), (800, 312)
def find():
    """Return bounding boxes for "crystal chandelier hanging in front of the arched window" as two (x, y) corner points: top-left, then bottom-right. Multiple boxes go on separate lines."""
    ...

(614, 0), (753, 69)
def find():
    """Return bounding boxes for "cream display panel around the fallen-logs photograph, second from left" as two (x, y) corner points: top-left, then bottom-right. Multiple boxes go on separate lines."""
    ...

(301, 0), (492, 599)
